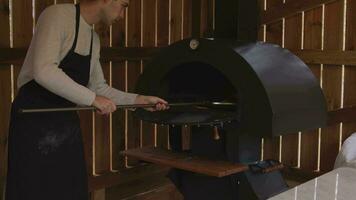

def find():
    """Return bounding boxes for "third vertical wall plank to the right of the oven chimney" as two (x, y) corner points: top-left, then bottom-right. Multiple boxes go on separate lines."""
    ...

(300, 7), (322, 170)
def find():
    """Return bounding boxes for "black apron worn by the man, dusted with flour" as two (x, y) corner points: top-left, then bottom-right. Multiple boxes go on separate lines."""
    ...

(5, 4), (93, 200)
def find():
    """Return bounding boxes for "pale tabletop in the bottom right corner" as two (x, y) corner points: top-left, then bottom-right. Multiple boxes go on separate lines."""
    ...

(270, 167), (356, 200)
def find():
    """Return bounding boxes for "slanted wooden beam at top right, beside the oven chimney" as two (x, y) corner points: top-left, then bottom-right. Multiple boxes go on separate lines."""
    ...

(261, 0), (336, 24)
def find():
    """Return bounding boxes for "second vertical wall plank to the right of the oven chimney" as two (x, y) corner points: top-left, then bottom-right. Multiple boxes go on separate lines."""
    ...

(282, 14), (302, 167)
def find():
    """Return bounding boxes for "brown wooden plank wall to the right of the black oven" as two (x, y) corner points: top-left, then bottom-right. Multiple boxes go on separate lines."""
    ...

(259, 0), (356, 173)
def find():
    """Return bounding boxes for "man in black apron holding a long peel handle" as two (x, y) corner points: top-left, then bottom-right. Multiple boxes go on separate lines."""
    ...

(5, 0), (168, 200)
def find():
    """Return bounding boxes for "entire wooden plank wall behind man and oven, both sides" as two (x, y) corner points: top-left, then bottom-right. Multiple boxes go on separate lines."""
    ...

(0, 0), (356, 196)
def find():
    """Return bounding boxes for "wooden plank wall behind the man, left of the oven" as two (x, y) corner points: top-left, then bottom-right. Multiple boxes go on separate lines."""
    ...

(0, 0), (214, 199)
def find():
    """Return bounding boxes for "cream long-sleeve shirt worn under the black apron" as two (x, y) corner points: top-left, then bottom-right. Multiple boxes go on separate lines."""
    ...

(17, 4), (137, 105)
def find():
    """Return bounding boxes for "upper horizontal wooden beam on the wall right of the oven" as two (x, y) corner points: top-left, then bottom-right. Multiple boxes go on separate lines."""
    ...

(292, 50), (356, 67)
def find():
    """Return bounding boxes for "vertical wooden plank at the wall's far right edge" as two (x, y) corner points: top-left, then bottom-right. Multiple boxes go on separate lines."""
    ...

(342, 0), (356, 141)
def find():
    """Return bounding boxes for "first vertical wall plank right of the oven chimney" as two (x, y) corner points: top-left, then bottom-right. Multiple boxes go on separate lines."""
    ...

(264, 21), (283, 160)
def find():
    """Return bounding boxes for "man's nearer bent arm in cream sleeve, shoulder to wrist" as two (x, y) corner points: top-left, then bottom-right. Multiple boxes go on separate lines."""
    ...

(31, 6), (95, 105)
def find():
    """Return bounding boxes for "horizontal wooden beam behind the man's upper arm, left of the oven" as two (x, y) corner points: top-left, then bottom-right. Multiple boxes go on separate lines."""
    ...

(0, 47), (160, 65)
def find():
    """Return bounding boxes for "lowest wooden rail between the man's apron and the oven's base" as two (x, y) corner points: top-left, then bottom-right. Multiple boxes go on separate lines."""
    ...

(88, 164), (169, 191)
